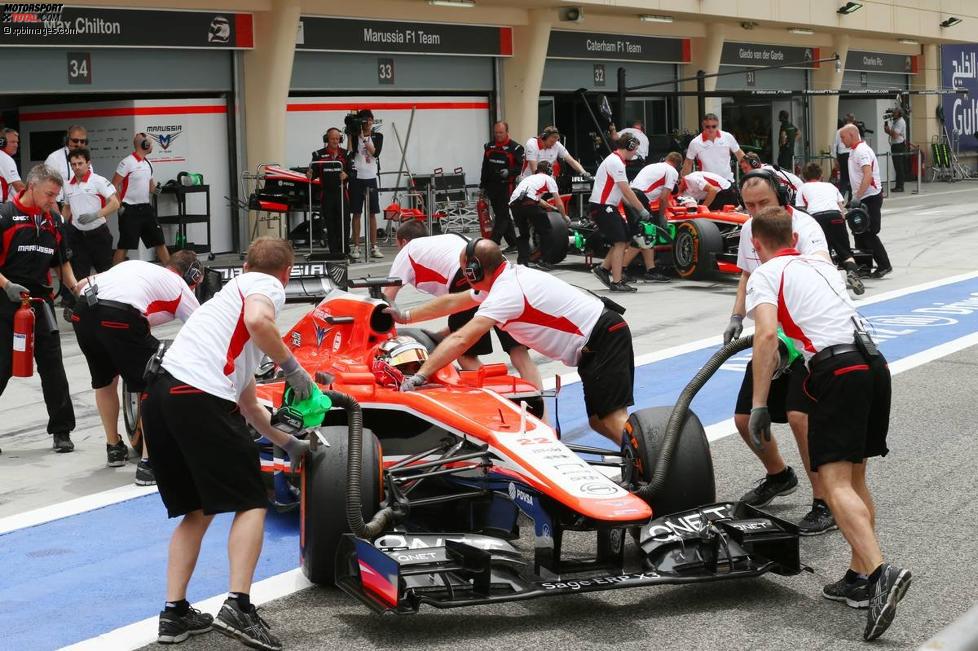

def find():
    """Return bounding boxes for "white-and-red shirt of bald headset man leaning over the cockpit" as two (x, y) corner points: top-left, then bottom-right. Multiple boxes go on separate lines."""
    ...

(472, 264), (604, 366)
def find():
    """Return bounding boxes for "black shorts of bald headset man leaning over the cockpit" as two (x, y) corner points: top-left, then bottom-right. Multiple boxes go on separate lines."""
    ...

(577, 309), (635, 418)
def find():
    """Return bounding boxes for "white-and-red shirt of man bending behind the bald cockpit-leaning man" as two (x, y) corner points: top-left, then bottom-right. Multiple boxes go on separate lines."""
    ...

(387, 234), (468, 296)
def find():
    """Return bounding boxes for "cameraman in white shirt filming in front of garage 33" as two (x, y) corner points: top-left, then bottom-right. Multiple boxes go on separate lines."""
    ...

(346, 109), (384, 260)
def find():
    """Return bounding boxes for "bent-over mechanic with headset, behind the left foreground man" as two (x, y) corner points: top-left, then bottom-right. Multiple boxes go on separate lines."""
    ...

(68, 252), (203, 486)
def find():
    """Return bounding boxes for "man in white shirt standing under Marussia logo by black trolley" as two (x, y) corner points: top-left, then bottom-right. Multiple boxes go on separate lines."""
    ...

(112, 132), (170, 265)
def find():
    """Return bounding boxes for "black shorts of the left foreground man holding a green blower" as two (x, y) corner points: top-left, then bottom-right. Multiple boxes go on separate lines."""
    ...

(142, 372), (268, 518)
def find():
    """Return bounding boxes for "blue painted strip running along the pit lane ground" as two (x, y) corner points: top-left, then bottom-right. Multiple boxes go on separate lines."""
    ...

(0, 278), (978, 649)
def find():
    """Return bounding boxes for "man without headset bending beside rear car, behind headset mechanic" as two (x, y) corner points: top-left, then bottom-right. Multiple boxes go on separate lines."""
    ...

(621, 151), (683, 283)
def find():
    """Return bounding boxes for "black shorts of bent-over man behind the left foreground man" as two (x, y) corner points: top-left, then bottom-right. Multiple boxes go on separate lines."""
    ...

(71, 298), (160, 391)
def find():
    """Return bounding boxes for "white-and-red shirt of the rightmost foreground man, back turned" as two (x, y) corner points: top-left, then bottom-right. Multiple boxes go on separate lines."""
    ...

(747, 249), (858, 361)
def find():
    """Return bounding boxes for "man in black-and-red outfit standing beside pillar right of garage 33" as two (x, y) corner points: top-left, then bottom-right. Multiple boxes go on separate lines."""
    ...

(479, 122), (523, 252)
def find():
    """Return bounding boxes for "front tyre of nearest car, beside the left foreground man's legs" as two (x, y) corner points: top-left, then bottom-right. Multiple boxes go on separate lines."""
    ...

(299, 426), (383, 586)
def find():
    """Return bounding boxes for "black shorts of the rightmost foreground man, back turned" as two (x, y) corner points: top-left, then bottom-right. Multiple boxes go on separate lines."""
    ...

(805, 352), (890, 470)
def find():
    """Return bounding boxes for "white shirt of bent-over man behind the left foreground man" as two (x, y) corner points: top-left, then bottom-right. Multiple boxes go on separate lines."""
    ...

(89, 260), (200, 326)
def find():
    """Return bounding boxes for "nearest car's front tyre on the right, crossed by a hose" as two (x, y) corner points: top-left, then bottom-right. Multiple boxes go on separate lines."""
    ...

(623, 407), (716, 517)
